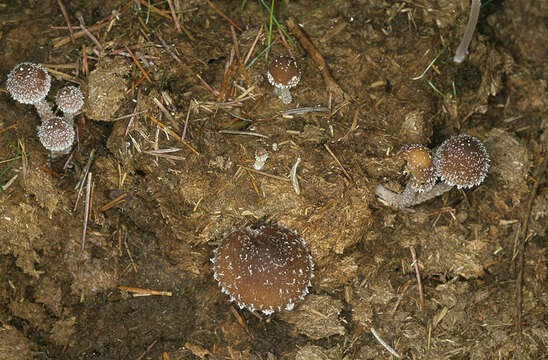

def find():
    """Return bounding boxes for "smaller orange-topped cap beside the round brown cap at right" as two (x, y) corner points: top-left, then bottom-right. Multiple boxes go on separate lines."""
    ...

(399, 144), (438, 192)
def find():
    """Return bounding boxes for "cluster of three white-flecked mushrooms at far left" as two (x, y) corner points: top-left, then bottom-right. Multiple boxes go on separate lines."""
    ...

(7, 62), (84, 154)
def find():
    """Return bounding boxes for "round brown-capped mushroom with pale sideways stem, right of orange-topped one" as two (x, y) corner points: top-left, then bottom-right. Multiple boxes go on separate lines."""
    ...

(375, 134), (489, 208)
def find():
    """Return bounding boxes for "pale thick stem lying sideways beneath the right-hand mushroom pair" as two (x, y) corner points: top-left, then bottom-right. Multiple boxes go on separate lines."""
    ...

(375, 182), (453, 209)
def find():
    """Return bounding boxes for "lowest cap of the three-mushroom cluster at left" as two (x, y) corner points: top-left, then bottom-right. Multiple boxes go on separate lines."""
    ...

(38, 116), (74, 153)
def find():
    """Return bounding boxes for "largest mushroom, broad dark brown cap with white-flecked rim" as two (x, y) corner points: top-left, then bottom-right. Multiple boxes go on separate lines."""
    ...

(211, 225), (314, 315)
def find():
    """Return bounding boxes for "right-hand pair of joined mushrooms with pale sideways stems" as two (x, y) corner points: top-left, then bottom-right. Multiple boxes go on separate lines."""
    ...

(375, 134), (489, 208)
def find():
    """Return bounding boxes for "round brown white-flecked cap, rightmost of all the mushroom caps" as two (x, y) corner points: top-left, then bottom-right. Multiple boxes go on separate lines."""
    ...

(435, 134), (489, 189)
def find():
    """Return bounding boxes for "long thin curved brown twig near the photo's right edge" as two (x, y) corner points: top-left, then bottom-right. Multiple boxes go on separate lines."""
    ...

(515, 155), (548, 336)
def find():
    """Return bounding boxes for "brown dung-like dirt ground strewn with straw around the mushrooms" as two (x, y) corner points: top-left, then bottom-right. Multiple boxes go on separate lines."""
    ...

(0, 0), (548, 360)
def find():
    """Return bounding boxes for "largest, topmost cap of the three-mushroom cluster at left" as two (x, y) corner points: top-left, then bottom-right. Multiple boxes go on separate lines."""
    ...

(7, 62), (51, 104)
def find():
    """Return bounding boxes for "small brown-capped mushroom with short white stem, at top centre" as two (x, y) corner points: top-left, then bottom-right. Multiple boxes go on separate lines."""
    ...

(266, 55), (301, 105)
